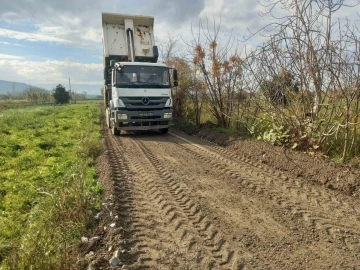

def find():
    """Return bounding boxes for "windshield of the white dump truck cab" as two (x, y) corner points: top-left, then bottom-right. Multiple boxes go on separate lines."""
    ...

(116, 66), (170, 88)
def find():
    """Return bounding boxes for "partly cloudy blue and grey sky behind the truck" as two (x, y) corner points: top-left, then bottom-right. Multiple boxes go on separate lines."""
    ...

(0, 0), (360, 94)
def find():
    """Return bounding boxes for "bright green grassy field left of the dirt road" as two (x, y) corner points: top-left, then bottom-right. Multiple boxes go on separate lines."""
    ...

(0, 101), (101, 269)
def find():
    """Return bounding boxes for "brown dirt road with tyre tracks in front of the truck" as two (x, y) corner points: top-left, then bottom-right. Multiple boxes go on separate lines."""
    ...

(95, 127), (360, 269)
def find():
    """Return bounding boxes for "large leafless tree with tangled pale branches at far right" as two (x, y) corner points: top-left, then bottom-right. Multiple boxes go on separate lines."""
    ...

(244, 0), (359, 161)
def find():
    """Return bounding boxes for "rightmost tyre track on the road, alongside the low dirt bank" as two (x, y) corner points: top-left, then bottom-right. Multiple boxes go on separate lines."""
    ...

(168, 134), (360, 255)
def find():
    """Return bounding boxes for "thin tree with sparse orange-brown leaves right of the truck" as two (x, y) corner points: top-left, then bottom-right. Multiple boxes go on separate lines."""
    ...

(188, 20), (242, 127)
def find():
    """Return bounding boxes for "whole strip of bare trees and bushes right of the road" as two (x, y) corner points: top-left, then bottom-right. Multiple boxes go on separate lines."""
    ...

(164, 0), (360, 163)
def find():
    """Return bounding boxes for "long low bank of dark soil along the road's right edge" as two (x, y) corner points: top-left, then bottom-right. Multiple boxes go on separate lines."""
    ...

(182, 126), (360, 197)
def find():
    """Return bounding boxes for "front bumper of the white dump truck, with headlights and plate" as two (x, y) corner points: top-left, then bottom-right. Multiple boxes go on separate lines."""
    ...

(110, 109), (173, 130)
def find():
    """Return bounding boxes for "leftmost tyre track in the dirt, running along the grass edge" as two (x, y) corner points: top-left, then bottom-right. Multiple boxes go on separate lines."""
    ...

(106, 132), (167, 269)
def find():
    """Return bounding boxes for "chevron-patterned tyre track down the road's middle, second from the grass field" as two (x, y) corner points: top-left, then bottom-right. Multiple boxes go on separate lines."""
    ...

(120, 136), (245, 269)
